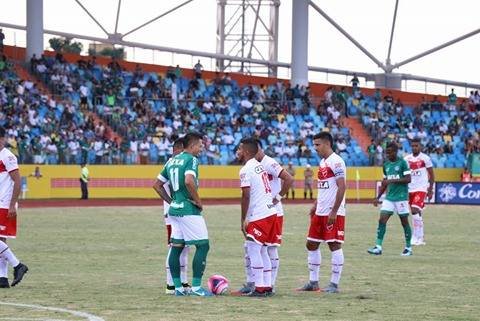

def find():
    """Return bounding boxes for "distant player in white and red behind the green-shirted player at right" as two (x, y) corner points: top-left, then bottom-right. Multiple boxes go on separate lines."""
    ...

(405, 138), (435, 245)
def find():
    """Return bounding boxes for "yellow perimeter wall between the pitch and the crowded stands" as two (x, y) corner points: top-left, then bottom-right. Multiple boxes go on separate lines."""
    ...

(20, 165), (462, 199)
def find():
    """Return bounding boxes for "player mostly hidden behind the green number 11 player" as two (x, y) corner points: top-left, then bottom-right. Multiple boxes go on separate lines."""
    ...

(153, 138), (190, 294)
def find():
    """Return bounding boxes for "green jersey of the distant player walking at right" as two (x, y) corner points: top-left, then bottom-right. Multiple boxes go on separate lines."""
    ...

(383, 158), (410, 202)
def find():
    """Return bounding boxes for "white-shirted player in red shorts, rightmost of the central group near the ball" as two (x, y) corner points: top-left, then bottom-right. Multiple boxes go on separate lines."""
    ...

(298, 132), (347, 293)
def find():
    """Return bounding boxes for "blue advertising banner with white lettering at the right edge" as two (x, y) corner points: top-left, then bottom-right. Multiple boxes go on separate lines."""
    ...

(435, 182), (480, 205)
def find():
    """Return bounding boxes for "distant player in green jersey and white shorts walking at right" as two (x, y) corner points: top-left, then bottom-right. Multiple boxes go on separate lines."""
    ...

(368, 142), (412, 256)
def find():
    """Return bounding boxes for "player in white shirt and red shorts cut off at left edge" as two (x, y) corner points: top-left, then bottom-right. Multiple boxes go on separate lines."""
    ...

(0, 127), (28, 288)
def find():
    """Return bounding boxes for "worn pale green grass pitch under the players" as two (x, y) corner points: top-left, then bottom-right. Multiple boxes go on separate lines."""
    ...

(0, 205), (480, 321)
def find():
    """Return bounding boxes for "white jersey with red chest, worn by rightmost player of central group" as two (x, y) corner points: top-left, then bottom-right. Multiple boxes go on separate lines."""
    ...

(315, 153), (347, 216)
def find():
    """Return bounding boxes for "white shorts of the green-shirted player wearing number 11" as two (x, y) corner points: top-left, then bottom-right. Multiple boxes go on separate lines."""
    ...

(169, 215), (208, 245)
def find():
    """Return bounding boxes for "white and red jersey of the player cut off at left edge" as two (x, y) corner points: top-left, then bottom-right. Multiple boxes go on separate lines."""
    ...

(0, 148), (18, 208)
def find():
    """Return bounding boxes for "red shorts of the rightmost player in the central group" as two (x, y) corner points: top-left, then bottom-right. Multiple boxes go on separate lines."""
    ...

(307, 215), (345, 243)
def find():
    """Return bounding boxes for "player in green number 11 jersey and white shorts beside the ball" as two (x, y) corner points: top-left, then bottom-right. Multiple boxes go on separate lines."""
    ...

(158, 133), (212, 296)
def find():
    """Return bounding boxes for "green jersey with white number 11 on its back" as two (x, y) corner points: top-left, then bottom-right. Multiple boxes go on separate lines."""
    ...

(158, 152), (201, 216)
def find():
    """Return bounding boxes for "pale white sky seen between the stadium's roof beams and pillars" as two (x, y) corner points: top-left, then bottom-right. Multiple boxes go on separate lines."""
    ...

(0, 0), (480, 96)
